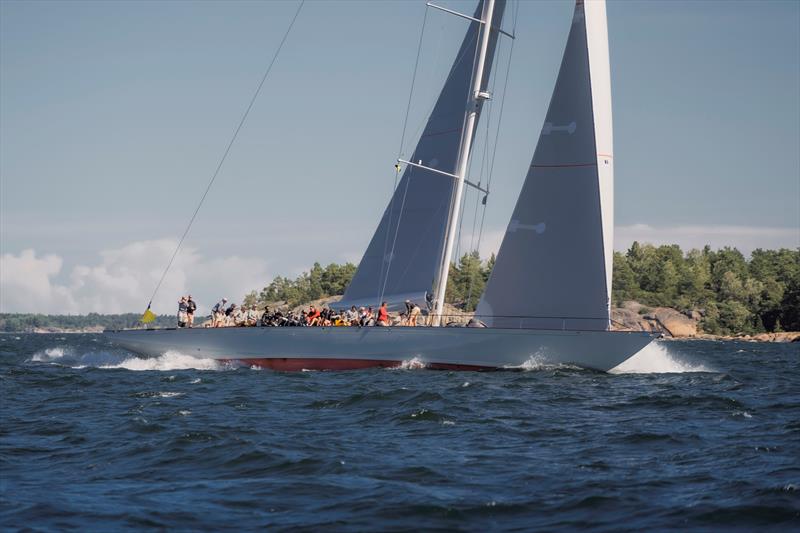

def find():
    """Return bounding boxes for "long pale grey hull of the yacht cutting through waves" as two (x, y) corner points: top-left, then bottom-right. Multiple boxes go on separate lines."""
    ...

(105, 327), (653, 371)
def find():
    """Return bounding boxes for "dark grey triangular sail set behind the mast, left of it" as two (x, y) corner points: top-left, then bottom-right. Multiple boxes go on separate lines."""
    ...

(338, 0), (505, 307)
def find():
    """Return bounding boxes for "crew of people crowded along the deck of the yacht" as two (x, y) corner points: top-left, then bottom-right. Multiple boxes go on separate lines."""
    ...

(178, 296), (423, 328)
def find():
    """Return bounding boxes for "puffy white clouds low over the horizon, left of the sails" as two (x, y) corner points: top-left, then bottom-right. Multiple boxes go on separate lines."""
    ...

(0, 240), (270, 314)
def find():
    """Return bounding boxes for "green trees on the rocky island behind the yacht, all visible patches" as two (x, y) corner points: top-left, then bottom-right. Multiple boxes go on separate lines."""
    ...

(244, 242), (800, 334)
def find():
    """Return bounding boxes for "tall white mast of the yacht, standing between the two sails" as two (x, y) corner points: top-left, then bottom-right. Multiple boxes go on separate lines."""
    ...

(434, 0), (494, 326)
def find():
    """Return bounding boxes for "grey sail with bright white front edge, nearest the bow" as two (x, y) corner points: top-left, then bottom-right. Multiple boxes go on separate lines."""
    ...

(476, 0), (614, 330)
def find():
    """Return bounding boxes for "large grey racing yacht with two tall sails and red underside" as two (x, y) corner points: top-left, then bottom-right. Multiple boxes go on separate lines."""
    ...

(106, 0), (653, 371)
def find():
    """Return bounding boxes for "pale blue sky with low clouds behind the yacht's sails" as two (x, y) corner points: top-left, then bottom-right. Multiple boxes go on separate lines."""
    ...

(0, 0), (800, 312)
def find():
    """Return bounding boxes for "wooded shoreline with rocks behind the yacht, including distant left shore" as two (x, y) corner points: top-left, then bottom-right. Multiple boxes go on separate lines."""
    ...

(0, 242), (800, 342)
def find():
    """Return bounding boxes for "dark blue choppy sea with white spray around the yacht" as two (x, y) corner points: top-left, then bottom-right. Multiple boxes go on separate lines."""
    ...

(0, 335), (800, 531)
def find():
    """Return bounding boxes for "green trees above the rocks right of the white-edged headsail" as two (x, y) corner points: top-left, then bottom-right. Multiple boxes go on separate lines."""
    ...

(612, 242), (800, 334)
